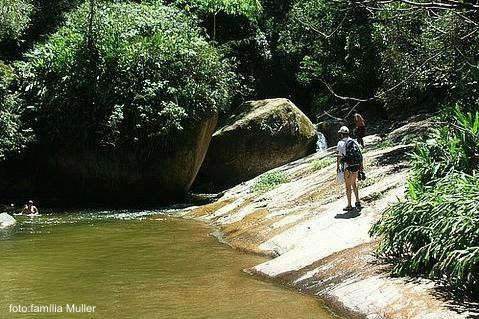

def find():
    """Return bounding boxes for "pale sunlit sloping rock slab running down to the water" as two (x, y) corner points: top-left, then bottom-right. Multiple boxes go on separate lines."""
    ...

(186, 123), (477, 319)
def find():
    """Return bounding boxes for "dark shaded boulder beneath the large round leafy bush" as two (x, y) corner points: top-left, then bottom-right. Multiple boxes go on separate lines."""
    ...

(42, 114), (218, 203)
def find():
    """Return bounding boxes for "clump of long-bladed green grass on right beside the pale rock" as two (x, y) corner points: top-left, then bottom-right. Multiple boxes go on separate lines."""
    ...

(370, 109), (479, 293)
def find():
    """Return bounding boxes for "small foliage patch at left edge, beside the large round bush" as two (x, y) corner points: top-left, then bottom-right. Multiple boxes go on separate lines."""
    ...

(0, 62), (32, 162)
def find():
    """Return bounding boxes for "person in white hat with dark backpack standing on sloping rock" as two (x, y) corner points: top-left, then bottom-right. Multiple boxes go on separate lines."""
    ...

(336, 126), (363, 211)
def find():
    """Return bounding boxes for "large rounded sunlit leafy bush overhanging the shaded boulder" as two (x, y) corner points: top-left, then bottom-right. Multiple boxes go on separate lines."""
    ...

(20, 3), (239, 150)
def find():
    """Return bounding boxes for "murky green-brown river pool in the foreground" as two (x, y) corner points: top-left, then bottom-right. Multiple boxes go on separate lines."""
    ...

(0, 212), (336, 319)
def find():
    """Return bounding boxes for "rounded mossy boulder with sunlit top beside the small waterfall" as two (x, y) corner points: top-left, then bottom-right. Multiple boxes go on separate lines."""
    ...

(201, 99), (317, 186)
